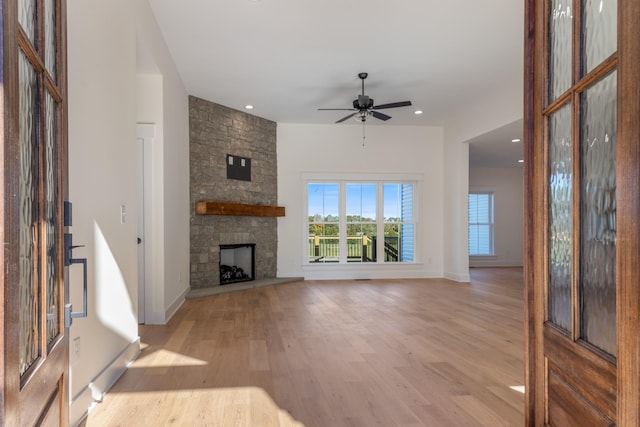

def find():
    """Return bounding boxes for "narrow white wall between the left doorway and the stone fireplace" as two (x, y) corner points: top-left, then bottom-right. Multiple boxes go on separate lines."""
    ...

(131, 1), (190, 323)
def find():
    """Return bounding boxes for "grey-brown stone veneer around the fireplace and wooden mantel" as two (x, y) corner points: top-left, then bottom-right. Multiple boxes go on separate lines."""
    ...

(189, 96), (278, 288)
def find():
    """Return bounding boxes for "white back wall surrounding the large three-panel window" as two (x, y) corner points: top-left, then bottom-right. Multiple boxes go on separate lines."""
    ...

(277, 124), (448, 279)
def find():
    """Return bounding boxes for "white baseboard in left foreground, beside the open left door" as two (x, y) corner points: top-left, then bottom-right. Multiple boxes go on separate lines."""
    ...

(69, 338), (140, 426)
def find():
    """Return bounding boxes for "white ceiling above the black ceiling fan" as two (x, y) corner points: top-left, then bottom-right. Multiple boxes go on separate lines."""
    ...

(149, 0), (524, 166)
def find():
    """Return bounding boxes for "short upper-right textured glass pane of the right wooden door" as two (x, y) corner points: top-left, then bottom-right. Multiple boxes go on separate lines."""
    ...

(582, 0), (618, 75)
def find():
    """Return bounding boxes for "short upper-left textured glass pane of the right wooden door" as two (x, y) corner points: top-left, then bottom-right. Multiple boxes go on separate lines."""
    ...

(549, 0), (573, 101)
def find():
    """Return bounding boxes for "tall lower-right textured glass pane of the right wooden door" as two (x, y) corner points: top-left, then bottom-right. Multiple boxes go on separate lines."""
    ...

(580, 72), (617, 355)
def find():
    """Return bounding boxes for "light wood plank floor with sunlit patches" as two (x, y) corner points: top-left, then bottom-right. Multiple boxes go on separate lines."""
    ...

(84, 268), (524, 427)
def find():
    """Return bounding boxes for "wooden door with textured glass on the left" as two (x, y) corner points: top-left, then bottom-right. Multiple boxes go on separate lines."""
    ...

(0, 0), (69, 426)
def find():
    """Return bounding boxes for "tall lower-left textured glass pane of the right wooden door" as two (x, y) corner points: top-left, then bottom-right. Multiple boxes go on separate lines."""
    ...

(549, 104), (573, 331)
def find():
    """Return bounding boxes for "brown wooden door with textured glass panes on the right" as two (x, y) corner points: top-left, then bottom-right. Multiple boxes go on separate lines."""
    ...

(525, 0), (640, 426)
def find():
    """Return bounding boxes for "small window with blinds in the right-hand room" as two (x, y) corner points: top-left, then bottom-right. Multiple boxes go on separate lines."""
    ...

(469, 192), (494, 255)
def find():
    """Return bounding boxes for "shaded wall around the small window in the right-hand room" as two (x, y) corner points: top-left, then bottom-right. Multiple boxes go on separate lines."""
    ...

(469, 168), (523, 267)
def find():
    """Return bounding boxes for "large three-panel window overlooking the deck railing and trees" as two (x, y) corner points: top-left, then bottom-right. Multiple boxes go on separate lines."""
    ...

(306, 181), (415, 263)
